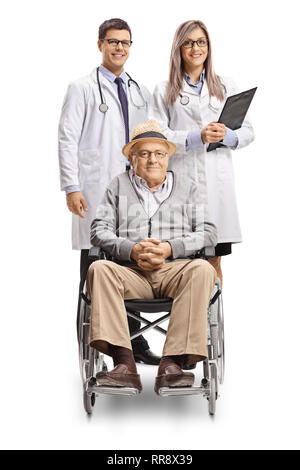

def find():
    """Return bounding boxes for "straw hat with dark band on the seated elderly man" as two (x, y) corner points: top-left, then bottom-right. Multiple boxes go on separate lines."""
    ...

(122, 120), (177, 157)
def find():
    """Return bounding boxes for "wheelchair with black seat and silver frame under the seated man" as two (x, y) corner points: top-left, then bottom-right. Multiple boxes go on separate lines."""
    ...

(77, 247), (225, 415)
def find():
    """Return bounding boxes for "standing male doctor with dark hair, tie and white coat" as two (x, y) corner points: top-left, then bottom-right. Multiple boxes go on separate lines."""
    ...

(59, 18), (160, 364)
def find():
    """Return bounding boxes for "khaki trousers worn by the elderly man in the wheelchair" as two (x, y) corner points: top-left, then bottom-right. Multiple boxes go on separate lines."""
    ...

(87, 259), (216, 364)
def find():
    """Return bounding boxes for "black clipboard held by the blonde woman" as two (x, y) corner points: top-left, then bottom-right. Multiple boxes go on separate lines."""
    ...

(206, 87), (257, 152)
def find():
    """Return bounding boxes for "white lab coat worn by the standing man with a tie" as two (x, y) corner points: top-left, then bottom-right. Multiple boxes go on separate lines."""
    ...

(59, 68), (150, 250)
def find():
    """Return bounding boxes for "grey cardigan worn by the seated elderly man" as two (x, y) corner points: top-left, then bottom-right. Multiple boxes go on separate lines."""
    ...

(91, 172), (217, 264)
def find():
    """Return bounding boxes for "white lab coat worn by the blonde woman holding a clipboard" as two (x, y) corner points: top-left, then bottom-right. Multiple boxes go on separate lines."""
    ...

(149, 77), (254, 243)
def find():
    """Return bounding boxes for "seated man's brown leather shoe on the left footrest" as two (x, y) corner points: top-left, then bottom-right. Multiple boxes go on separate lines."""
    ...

(96, 364), (143, 392)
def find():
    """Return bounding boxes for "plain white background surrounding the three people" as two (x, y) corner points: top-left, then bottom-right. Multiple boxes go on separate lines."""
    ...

(0, 0), (300, 449)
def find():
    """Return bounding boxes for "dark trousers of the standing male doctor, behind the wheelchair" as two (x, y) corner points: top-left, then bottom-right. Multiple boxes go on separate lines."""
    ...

(77, 250), (149, 352)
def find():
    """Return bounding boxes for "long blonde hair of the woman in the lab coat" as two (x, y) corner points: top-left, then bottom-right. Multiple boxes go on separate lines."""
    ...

(165, 20), (224, 105)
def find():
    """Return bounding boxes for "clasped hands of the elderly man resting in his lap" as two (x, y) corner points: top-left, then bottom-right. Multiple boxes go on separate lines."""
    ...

(131, 238), (172, 271)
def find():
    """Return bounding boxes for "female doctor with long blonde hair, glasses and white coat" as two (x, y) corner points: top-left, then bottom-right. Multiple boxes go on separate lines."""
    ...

(150, 21), (254, 283)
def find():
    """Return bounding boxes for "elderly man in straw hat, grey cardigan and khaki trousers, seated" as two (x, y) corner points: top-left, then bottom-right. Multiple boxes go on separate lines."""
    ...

(82, 121), (217, 402)
